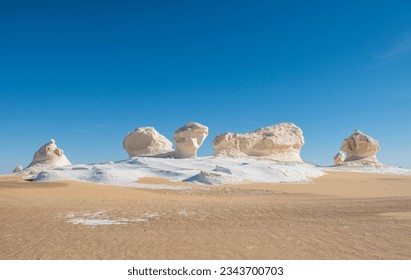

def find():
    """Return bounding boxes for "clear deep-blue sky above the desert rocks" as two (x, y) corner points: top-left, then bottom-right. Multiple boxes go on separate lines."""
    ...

(0, 0), (411, 173)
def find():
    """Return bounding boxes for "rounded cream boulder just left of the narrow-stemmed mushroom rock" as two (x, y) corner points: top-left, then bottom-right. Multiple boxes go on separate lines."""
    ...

(123, 127), (173, 157)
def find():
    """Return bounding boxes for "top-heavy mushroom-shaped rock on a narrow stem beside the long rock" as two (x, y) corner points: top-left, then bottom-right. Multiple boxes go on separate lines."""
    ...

(174, 122), (208, 158)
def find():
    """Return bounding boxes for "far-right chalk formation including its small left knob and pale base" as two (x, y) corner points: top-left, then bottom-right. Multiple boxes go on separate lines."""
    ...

(334, 130), (382, 166)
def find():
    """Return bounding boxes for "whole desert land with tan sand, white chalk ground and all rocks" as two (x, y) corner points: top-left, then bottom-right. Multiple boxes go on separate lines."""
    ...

(0, 122), (411, 259)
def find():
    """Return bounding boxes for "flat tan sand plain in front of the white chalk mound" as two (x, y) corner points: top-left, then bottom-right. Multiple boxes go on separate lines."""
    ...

(0, 173), (411, 259)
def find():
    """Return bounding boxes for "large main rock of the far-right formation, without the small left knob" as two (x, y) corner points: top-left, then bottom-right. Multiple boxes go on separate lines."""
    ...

(341, 130), (380, 163)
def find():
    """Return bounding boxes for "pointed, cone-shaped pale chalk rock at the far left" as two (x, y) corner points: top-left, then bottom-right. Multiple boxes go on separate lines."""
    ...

(26, 139), (71, 173)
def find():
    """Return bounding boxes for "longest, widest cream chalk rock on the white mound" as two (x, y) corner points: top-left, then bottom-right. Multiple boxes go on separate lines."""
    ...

(213, 123), (304, 162)
